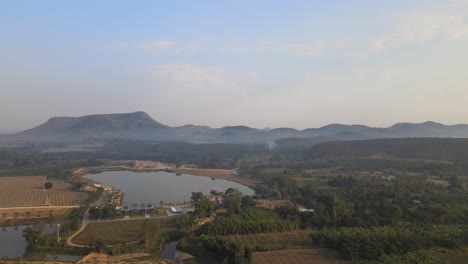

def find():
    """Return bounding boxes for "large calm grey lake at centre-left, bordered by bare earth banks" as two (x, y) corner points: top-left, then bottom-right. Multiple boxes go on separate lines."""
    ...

(84, 171), (254, 208)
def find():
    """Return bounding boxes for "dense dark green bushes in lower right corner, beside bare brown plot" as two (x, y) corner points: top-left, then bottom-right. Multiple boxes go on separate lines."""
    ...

(312, 224), (468, 260)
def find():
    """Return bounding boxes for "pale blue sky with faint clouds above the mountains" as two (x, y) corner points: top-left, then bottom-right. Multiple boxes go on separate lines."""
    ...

(0, 0), (468, 133)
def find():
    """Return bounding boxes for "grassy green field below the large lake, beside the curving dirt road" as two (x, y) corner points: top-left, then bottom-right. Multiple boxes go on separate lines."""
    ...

(73, 218), (176, 245)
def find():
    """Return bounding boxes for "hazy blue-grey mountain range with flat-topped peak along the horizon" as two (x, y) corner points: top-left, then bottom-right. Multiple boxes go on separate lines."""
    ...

(3, 112), (468, 147)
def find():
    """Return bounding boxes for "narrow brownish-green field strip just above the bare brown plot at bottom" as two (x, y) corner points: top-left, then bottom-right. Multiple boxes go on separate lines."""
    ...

(225, 229), (314, 250)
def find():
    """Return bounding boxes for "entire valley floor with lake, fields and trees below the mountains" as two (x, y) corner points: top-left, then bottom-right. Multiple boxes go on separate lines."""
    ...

(0, 113), (468, 264)
